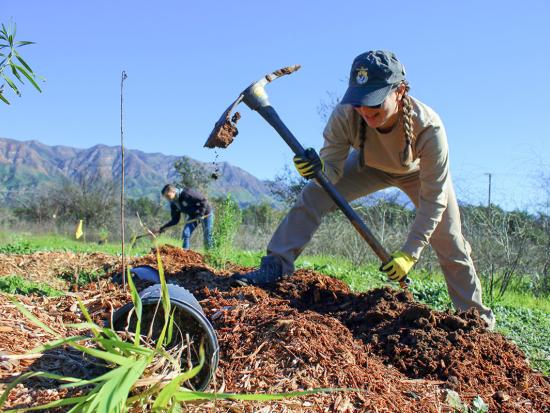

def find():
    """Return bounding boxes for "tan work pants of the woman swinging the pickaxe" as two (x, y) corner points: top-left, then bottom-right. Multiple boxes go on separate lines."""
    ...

(267, 151), (495, 328)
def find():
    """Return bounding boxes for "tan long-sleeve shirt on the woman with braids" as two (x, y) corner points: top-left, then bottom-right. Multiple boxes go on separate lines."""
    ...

(320, 98), (451, 259)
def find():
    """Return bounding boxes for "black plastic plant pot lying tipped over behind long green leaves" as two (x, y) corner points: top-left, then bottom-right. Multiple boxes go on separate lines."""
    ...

(113, 284), (219, 390)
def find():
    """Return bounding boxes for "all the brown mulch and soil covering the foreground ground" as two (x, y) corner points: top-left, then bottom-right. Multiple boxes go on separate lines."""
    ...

(0, 247), (550, 413)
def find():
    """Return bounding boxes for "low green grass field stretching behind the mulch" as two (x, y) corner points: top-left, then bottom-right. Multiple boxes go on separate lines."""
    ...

(0, 233), (550, 375)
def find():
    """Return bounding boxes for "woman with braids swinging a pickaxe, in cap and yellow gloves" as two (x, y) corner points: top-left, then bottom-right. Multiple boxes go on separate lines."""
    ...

(235, 50), (495, 328)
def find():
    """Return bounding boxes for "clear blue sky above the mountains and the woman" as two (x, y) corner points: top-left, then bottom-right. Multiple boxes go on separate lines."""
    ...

(0, 0), (550, 210)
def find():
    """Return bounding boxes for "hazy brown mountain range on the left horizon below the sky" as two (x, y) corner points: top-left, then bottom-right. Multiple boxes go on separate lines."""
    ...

(0, 138), (273, 205)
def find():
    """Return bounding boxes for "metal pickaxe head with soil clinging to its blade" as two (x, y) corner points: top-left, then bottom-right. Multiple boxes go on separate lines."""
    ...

(204, 65), (301, 148)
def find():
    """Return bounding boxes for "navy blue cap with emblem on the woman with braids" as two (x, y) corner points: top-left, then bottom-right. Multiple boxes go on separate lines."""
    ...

(341, 50), (405, 106)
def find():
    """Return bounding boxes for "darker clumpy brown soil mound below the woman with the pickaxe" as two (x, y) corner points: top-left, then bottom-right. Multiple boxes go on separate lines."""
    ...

(276, 271), (550, 412)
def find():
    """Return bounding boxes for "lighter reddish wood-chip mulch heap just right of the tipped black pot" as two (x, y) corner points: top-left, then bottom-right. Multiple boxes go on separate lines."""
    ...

(203, 287), (440, 412)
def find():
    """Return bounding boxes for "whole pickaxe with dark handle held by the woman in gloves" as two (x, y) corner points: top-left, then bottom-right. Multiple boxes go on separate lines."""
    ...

(204, 65), (410, 289)
